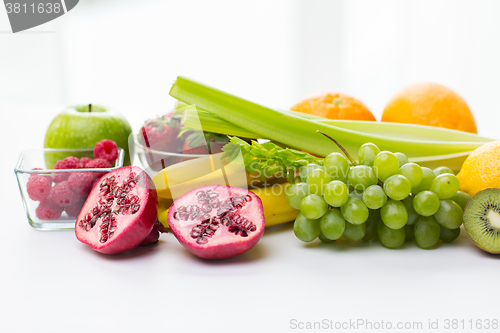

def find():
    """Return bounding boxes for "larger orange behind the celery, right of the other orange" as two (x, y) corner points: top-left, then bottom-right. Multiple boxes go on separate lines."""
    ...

(382, 83), (477, 133)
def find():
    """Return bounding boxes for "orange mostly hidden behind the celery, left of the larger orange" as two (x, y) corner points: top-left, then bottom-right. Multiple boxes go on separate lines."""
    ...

(290, 93), (376, 121)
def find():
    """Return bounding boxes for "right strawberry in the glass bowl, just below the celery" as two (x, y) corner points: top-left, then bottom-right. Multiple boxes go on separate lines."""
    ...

(182, 131), (229, 155)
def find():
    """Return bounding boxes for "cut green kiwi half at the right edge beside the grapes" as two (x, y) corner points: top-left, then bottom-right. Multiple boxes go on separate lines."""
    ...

(464, 188), (500, 253)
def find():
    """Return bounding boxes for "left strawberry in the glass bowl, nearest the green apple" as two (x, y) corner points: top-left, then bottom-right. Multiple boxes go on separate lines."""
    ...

(139, 112), (182, 152)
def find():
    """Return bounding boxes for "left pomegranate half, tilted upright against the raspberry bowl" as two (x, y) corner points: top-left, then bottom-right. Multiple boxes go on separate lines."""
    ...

(75, 166), (157, 254)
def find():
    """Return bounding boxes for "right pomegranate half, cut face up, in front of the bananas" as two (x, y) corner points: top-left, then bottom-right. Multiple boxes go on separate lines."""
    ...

(168, 185), (265, 259)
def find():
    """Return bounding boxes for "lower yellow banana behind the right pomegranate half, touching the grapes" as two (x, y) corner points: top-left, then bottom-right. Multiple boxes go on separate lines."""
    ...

(158, 183), (299, 228)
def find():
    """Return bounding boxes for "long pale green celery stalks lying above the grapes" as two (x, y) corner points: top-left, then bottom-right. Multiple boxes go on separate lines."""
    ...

(170, 76), (483, 157)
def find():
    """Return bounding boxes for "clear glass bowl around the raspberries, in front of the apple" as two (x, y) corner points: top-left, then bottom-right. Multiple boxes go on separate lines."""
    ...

(14, 148), (125, 230)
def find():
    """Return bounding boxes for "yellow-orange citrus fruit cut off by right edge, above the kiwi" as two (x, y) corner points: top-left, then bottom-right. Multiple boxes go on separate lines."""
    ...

(457, 141), (500, 195)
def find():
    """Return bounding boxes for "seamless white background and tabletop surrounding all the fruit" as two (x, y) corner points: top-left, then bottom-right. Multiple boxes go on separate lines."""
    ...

(0, 0), (500, 332)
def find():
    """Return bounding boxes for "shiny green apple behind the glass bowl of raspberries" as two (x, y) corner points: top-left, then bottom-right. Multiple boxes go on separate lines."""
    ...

(44, 104), (133, 169)
